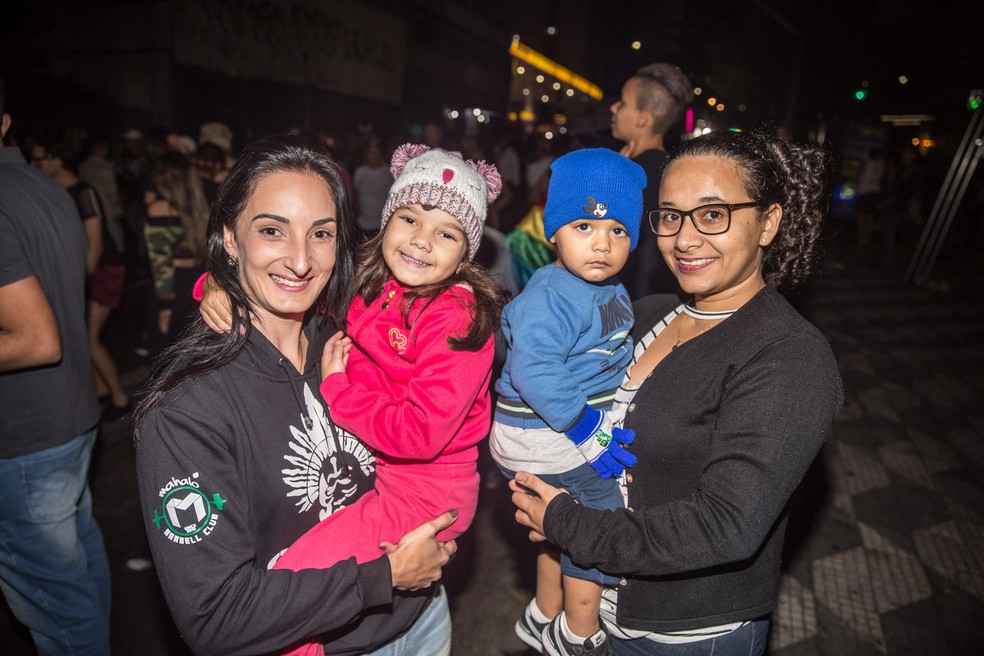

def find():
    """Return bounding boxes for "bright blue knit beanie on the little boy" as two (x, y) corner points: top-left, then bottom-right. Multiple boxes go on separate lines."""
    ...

(543, 148), (646, 250)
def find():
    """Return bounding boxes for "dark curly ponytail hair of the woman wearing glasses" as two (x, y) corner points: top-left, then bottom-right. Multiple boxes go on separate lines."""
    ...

(664, 129), (830, 288)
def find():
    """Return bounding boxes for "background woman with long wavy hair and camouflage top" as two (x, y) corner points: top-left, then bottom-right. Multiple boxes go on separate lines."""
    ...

(144, 151), (208, 355)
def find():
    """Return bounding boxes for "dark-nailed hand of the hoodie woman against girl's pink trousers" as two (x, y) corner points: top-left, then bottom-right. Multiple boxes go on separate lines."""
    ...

(379, 510), (458, 590)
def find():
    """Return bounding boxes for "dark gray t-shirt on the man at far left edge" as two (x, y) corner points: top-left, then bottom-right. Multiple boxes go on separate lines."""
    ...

(0, 147), (99, 458)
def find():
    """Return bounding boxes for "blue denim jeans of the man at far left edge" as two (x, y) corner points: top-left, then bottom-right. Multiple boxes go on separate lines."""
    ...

(0, 429), (110, 656)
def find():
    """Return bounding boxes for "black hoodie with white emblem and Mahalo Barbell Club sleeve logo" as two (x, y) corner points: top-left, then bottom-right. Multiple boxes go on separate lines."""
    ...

(137, 322), (431, 656)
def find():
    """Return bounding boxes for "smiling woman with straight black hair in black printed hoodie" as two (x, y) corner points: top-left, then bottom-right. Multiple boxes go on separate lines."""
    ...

(135, 136), (456, 654)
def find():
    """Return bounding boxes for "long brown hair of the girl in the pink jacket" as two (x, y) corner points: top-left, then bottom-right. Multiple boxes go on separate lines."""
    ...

(355, 219), (508, 351)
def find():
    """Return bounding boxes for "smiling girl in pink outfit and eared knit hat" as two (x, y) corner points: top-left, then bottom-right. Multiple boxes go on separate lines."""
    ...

(203, 144), (504, 654)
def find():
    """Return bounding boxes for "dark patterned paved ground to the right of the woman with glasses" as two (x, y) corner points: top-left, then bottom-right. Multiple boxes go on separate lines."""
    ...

(770, 253), (984, 656)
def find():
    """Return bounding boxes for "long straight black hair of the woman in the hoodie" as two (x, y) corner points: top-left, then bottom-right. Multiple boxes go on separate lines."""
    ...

(134, 135), (354, 437)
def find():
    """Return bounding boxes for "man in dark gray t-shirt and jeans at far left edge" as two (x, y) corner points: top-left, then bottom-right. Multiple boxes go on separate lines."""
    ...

(0, 75), (110, 655)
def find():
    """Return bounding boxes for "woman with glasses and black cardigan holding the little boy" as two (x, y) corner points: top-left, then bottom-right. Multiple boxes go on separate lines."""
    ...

(510, 131), (843, 656)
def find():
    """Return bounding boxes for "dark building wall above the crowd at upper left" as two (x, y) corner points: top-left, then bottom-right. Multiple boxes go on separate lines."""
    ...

(0, 0), (518, 140)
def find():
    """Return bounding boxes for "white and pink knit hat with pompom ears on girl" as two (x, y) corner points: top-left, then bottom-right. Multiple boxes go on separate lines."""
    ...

(382, 144), (502, 259)
